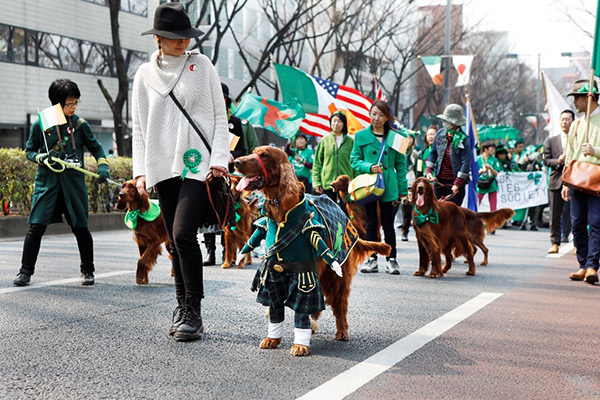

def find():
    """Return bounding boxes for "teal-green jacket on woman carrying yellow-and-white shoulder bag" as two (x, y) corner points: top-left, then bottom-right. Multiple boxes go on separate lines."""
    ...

(350, 125), (408, 202)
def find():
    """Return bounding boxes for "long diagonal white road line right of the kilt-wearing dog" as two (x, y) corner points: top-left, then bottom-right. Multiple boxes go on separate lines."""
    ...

(299, 293), (502, 400)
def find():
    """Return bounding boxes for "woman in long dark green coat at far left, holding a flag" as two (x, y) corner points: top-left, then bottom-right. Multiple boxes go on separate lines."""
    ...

(13, 79), (110, 286)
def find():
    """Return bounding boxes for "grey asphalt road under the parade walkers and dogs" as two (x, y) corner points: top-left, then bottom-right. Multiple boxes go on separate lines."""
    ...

(0, 223), (600, 400)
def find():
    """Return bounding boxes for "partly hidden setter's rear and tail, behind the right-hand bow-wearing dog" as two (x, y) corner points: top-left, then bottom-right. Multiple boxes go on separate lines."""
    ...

(461, 207), (515, 265)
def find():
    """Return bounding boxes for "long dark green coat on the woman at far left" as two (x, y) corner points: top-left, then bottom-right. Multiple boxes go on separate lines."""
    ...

(25, 115), (106, 228)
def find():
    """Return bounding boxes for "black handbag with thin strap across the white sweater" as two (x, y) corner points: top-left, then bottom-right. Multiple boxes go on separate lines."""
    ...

(169, 92), (235, 228)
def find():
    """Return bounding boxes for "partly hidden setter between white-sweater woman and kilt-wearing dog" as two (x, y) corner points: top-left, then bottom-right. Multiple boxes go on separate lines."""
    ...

(221, 175), (258, 269)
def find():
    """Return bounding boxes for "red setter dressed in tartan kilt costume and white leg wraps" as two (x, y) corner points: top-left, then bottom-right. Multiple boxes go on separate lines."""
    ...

(235, 146), (391, 356)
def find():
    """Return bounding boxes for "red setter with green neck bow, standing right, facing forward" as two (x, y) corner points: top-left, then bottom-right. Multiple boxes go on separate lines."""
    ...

(412, 177), (475, 278)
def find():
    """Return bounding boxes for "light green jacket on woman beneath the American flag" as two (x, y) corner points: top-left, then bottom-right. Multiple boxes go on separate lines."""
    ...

(312, 133), (354, 190)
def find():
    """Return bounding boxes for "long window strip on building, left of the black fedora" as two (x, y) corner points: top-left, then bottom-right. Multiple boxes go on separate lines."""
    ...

(0, 24), (148, 78)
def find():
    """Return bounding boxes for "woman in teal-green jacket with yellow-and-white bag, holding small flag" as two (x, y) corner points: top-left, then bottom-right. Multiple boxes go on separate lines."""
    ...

(350, 100), (409, 275)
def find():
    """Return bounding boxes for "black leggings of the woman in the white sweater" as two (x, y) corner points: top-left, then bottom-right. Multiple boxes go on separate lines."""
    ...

(155, 178), (211, 300)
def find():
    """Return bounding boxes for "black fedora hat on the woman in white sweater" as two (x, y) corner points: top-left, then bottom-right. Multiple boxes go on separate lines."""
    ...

(142, 3), (204, 39)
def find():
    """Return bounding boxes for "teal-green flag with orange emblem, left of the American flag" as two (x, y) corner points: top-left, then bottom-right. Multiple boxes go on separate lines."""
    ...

(235, 93), (306, 139)
